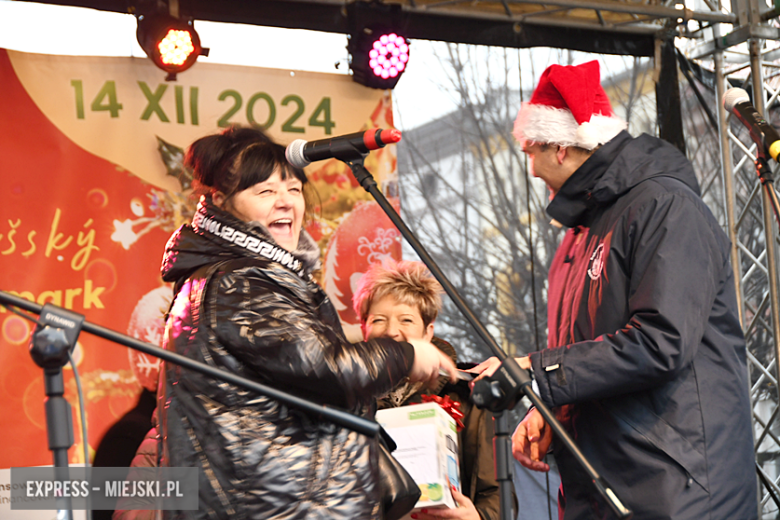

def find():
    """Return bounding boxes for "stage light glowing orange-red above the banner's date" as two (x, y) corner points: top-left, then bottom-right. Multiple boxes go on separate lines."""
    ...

(136, 13), (209, 81)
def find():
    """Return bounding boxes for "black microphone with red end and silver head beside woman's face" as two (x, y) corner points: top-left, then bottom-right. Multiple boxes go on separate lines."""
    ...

(285, 128), (401, 168)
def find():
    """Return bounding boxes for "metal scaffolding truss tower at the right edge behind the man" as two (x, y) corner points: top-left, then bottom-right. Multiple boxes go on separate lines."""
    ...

(687, 0), (780, 519)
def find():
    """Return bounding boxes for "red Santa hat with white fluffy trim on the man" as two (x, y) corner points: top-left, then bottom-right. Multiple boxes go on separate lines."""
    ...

(512, 61), (627, 150)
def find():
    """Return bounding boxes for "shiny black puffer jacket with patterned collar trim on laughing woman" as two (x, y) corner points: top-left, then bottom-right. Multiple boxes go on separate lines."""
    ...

(158, 199), (414, 520)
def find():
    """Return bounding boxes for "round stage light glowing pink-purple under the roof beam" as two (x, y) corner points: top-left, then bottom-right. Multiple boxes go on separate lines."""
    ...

(347, 26), (409, 89)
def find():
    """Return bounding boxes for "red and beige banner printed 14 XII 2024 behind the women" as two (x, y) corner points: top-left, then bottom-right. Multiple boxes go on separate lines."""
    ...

(0, 49), (401, 476)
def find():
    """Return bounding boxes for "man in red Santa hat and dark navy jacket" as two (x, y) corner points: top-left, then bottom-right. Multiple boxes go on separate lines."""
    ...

(478, 61), (758, 520)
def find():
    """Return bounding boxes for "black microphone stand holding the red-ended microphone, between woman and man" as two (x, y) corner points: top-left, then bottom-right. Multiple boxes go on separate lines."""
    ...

(333, 147), (633, 520)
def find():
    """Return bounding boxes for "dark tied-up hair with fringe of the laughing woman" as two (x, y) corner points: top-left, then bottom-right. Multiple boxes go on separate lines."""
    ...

(184, 126), (308, 199)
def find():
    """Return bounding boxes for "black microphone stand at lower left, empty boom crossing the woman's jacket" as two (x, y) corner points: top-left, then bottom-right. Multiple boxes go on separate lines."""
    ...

(0, 291), (380, 520)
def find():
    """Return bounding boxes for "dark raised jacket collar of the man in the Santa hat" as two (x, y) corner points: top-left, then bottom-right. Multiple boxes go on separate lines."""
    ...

(547, 131), (632, 227)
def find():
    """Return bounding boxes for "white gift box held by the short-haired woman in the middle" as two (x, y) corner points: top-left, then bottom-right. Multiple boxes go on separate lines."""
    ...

(376, 403), (460, 510)
